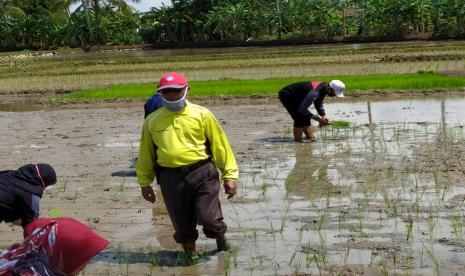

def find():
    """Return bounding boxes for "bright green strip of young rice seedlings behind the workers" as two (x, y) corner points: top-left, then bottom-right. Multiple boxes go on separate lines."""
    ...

(57, 73), (465, 101)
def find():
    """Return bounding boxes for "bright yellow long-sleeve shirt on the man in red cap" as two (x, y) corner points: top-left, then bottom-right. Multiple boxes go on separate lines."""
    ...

(136, 102), (239, 187)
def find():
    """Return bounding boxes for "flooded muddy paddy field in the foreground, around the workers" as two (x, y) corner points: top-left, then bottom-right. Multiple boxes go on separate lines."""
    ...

(0, 95), (465, 275)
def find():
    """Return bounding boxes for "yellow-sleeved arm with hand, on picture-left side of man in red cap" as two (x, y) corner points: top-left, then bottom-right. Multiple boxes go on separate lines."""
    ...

(136, 120), (156, 203)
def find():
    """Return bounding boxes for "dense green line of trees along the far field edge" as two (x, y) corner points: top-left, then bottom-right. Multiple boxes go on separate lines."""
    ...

(0, 0), (465, 50)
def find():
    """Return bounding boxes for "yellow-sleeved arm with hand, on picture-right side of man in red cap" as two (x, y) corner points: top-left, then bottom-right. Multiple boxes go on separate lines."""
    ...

(204, 112), (239, 199)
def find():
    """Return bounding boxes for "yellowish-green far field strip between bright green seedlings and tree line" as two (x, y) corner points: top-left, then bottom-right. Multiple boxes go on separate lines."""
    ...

(0, 41), (465, 94)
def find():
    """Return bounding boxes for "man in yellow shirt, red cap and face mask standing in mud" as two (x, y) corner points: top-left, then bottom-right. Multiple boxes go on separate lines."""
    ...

(136, 72), (239, 256)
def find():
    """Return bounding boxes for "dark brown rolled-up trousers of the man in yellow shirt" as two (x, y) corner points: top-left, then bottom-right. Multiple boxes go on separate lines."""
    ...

(159, 161), (227, 243)
